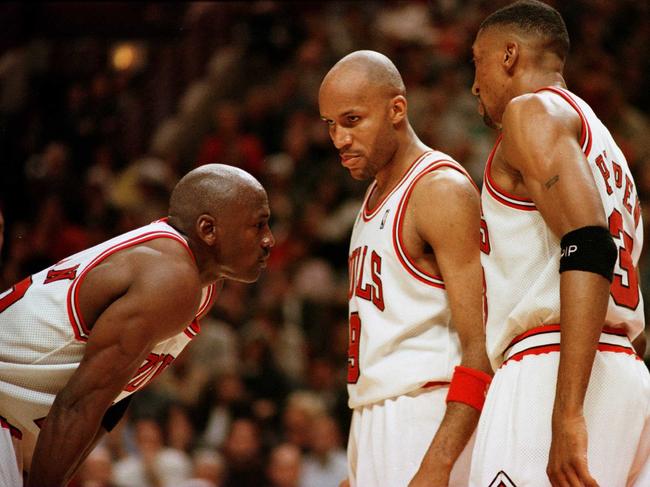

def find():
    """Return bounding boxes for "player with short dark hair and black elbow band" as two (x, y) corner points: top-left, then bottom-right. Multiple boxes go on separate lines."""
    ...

(471, 1), (650, 487)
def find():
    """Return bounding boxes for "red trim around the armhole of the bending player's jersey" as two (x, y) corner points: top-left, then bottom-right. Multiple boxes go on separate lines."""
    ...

(67, 230), (196, 342)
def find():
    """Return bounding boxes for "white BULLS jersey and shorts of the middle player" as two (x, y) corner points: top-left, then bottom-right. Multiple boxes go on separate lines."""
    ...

(348, 151), (469, 487)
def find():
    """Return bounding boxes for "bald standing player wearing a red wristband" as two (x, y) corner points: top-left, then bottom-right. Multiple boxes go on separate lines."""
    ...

(319, 51), (491, 487)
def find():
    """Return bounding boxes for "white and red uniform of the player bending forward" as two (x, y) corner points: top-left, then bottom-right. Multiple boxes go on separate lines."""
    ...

(0, 220), (215, 486)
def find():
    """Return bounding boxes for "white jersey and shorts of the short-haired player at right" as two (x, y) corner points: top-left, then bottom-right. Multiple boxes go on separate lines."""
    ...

(471, 88), (650, 487)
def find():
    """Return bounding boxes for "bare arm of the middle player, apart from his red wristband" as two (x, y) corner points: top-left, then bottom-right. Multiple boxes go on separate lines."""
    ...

(405, 168), (492, 487)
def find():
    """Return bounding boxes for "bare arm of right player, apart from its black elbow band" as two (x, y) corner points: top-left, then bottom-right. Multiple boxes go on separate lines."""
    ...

(500, 94), (610, 486)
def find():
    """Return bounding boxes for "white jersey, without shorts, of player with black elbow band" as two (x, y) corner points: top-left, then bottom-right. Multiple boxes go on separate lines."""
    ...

(481, 87), (645, 368)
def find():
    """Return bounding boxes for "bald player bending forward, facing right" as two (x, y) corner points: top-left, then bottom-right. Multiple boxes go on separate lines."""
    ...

(0, 164), (274, 487)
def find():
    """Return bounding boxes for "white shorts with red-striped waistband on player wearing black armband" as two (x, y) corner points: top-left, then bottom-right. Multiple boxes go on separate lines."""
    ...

(470, 325), (650, 487)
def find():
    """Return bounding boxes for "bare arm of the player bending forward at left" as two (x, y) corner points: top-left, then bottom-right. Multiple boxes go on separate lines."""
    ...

(28, 239), (201, 487)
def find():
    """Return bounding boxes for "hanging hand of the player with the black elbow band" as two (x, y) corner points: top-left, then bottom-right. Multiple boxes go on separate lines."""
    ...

(546, 415), (598, 487)
